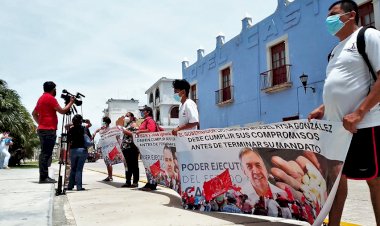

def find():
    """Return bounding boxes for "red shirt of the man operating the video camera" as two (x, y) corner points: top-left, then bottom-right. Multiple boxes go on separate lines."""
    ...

(34, 93), (59, 130)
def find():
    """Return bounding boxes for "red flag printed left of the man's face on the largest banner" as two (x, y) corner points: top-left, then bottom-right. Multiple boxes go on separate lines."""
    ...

(203, 169), (232, 201)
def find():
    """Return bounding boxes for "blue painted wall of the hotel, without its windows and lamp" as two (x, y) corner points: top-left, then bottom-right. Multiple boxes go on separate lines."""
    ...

(182, 0), (338, 129)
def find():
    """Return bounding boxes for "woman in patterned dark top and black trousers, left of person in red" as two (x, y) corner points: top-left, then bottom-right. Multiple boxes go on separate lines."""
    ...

(121, 112), (140, 188)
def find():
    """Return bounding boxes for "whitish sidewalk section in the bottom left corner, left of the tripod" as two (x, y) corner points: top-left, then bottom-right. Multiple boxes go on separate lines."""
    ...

(0, 168), (55, 226)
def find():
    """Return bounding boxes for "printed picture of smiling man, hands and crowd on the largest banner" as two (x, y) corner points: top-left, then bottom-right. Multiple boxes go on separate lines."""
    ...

(180, 147), (343, 224)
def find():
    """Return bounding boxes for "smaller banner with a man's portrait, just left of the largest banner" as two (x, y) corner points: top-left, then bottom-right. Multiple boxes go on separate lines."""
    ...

(134, 132), (181, 193)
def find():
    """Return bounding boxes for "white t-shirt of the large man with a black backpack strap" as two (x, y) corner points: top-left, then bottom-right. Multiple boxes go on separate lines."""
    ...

(323, 29), (380, 129)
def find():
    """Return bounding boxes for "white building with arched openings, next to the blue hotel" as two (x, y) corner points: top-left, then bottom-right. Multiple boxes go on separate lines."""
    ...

(145, 77), (179, 130)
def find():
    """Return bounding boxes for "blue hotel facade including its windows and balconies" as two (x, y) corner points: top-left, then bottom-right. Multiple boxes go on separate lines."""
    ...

(182, 0), (380, 129)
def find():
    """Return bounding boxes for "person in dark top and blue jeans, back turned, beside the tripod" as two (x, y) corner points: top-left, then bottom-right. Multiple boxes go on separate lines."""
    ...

(67, 115), (91, 191)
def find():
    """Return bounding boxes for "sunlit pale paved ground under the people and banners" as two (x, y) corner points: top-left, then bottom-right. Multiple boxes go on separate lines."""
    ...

(0, 160), (375, 226)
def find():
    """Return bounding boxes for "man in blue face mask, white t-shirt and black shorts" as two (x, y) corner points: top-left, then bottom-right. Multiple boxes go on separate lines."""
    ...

(308, 0), (380, 226)
